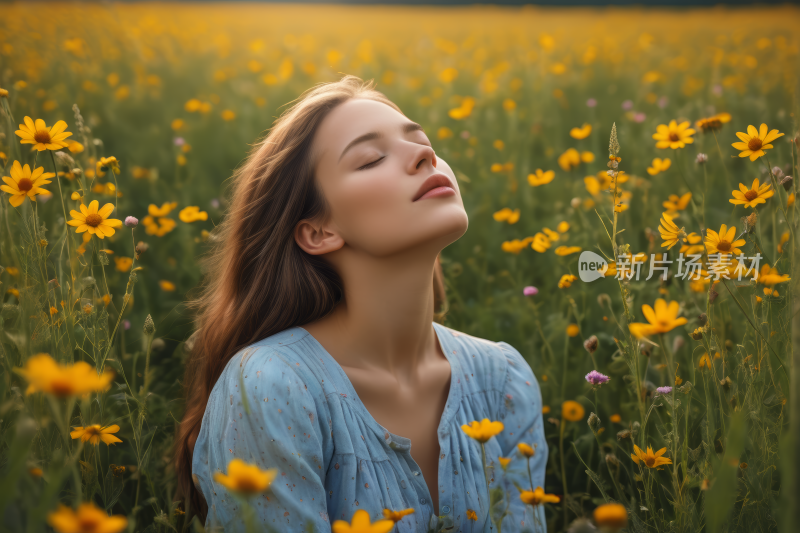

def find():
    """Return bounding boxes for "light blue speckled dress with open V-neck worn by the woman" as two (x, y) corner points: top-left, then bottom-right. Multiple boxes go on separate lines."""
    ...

(192, 322), (548, 533)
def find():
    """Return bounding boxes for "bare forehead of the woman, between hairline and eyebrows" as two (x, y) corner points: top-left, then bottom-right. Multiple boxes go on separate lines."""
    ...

(314, 98), (410, 159)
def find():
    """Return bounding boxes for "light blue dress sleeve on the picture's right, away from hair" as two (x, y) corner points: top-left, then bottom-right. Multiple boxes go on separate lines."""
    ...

(497, 341), (548, 533)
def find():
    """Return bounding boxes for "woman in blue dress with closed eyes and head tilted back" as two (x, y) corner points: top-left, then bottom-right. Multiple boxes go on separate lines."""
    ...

(176, 76), (547, 533)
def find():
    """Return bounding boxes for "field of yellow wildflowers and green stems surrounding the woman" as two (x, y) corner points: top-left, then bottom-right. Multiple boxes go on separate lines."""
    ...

(0, 2), (800, 533)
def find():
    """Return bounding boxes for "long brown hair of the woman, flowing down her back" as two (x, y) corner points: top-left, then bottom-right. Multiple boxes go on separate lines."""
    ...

(175, 75), (447, 520)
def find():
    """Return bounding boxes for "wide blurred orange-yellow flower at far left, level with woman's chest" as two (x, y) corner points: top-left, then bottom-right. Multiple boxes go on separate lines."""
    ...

(14, 353), (114, 398)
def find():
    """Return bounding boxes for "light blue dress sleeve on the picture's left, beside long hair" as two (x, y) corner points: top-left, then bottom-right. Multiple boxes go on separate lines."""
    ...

(192, 347), (331, 531)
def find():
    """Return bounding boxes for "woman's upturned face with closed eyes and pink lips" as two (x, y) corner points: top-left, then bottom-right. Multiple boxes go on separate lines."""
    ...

(303, 99), (468, 257)
